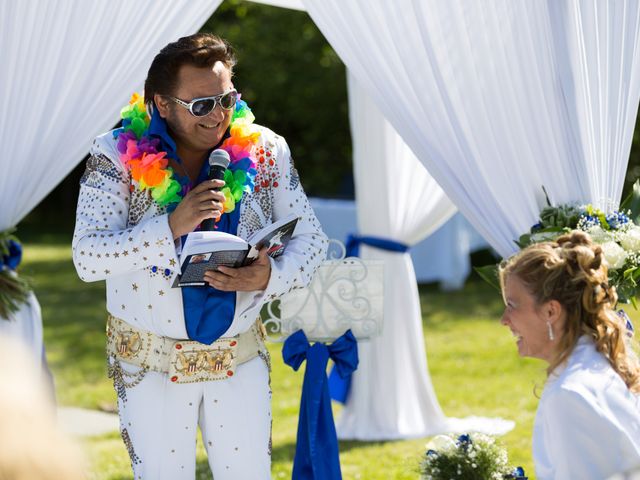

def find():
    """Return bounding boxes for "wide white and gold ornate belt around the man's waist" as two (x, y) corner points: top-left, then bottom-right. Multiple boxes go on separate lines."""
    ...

(107, 315), (268, 383)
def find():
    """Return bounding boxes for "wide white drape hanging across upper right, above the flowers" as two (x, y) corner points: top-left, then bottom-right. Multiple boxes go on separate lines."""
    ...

(303, 0), (640, 256)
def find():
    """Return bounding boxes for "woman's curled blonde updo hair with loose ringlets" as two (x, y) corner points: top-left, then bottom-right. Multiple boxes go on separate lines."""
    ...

(500, 231), (640, 392)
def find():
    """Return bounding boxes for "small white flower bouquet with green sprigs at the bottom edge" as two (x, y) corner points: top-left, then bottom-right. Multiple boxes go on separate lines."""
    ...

(420, 433), (527, 480)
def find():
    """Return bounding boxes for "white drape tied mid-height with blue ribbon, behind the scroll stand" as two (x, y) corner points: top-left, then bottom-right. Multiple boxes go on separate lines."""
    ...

(337, 75), (456, 440)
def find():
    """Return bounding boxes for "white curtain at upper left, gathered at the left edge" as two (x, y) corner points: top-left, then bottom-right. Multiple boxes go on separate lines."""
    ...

(0, 0), (222, 358)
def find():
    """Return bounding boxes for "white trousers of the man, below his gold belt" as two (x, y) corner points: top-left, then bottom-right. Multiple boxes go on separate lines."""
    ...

(116, 357), (271, 480)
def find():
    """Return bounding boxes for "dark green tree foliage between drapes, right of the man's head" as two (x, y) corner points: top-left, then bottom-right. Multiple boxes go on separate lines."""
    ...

(202, 0), (353, 197)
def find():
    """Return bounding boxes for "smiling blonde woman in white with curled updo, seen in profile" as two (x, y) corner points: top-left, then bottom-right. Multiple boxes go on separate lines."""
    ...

(500, 232), (640, 480)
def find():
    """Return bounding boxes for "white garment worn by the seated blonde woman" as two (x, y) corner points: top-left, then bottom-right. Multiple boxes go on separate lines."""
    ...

(533, 336), (640, 480)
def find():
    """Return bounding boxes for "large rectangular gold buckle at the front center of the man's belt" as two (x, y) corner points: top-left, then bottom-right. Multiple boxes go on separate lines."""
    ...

(169, 338), (238, 383)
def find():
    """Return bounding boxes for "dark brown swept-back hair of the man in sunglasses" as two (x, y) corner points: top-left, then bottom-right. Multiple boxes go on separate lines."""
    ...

(144, 33), (236, 105)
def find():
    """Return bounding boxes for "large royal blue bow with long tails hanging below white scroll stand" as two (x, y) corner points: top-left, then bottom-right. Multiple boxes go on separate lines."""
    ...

(282, 330), (358, 480)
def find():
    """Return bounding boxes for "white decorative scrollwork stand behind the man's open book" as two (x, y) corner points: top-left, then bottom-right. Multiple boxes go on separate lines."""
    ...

(263, 240), (383, 342)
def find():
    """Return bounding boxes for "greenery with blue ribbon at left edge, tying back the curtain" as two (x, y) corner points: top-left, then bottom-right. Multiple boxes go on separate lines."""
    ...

(0, 230), (31, 321)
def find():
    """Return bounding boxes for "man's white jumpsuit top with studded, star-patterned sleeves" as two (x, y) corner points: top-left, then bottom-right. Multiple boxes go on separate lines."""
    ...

(72, 127), (328, 339)
